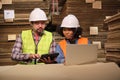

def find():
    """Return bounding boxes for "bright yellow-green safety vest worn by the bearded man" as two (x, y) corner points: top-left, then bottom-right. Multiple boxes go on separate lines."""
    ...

(22, 30), (52, 55)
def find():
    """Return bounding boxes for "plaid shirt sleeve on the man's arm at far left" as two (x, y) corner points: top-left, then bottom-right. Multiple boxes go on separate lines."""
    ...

(11, 35), (29, 61)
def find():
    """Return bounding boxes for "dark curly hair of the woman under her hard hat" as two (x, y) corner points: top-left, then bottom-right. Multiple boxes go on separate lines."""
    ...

(56, 26), (83, 38)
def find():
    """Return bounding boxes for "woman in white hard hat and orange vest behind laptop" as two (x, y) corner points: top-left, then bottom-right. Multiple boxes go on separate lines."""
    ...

(56, 14), (90, 63)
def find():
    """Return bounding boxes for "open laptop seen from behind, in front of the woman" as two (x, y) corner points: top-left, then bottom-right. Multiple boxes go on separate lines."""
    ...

(65, 44), (98, 65)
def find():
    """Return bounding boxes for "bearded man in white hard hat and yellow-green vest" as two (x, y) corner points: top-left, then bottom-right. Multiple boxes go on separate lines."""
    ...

(11, 8), (56, 64)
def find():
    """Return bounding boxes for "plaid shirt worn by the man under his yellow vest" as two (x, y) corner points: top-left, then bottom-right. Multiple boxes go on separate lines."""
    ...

(11, 30), (56, 62)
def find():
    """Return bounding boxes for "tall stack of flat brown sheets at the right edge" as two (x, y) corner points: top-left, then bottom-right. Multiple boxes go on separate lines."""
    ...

(105, 13), (120, 64)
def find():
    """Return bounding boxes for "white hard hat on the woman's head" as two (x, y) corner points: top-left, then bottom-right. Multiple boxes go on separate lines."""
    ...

(61, 14), (80, 28)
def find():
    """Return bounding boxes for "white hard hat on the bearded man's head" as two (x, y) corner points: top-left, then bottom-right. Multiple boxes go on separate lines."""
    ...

(29, 8), (47, 22)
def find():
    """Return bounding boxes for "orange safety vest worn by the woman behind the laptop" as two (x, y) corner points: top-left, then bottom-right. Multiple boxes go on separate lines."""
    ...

(59, 38), (88, 57)
